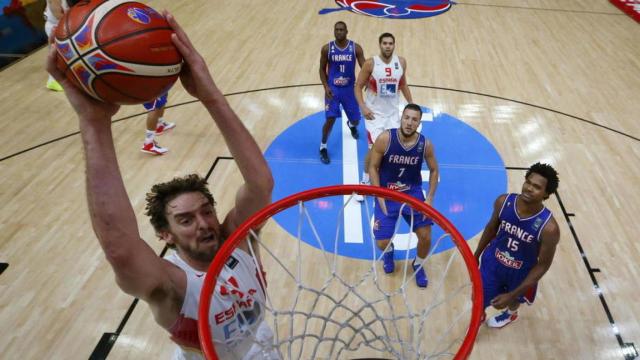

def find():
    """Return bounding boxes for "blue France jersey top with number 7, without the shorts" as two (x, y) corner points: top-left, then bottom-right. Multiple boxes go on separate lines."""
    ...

(380, 129), (427, 195)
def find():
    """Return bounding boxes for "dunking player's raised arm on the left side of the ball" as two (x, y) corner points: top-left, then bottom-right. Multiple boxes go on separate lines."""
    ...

(47, 41), (177, 300)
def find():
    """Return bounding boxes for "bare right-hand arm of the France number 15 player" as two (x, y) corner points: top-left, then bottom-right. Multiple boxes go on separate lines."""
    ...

(491, 217), (560, 309)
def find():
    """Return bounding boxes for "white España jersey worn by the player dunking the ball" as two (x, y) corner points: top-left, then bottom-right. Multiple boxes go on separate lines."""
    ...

(165, 249), (278, 360)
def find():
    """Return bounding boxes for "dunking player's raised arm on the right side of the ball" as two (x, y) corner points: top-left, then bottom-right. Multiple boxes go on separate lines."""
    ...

(165, 13), (273, 238)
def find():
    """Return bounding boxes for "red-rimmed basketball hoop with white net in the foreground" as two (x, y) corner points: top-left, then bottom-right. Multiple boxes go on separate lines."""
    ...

(198, 185), (483, 359)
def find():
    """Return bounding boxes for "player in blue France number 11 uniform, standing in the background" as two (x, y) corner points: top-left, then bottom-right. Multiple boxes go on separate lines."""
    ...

(320, 21), (364, 164)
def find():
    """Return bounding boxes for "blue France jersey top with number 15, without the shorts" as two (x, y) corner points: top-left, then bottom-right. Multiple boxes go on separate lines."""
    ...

(485, 194), (552, 271)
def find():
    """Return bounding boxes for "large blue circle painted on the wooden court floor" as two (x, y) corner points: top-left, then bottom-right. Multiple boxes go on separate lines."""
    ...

(265, 108), (507, 259)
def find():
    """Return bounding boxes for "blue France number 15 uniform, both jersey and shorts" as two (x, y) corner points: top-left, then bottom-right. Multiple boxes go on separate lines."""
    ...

(480, 194), (552, 308)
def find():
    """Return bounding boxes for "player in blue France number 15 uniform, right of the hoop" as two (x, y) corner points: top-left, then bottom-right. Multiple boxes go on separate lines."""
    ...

(474, 163), (560, 328)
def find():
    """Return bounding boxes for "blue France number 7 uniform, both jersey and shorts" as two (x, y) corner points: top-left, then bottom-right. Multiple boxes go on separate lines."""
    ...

(373, 129), (433, 240)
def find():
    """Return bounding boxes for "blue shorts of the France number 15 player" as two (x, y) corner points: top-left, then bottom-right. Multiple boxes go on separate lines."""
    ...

(480, 246), (538, 309)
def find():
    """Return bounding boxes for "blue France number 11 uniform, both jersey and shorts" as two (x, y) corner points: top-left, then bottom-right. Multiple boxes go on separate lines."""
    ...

(324, 40), (360, 125)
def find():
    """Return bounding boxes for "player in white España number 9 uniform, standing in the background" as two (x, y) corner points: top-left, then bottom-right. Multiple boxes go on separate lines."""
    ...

(354, 33), (413, 193)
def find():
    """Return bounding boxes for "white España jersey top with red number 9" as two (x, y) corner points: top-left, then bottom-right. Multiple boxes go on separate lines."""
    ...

(365, 55), (404, 116)
